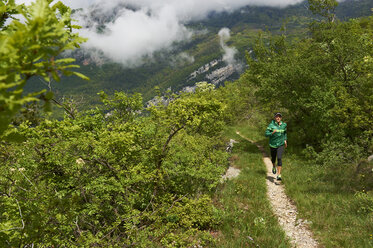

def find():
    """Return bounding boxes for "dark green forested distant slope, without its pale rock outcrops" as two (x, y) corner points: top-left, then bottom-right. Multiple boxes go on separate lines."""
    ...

(26, 0), (373, 105)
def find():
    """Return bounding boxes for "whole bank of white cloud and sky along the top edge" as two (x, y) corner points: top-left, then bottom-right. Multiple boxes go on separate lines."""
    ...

(17, 0), (342, 66)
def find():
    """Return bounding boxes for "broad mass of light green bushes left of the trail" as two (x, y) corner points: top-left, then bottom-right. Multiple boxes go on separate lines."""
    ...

(0, 85), (227, 247)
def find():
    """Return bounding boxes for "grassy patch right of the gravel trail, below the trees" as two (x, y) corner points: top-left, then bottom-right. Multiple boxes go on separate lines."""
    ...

(283, 156), (373, 247)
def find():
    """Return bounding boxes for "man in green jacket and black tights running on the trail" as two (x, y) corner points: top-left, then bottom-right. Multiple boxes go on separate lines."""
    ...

(265, 113), (287, 180)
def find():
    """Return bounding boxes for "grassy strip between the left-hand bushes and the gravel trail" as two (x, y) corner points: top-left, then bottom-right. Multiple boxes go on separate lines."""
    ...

(215, 127), (290, 248)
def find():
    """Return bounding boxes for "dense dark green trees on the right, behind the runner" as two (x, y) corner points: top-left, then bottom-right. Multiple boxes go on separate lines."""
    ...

(246, 12), (373, 162)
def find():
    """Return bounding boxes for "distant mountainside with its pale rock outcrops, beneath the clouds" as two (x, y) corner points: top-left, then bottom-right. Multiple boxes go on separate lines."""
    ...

(27, 0), (373, 105)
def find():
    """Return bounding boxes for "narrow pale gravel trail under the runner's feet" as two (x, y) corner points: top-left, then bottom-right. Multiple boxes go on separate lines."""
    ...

(237, 132), (319, 248)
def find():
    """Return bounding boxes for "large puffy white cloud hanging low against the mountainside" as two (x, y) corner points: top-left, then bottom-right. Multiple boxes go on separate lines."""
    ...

(80, 6), (190, 66)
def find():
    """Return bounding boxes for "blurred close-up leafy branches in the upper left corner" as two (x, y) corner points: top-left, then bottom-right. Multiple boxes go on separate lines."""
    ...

(0, 0), (86, 135)
